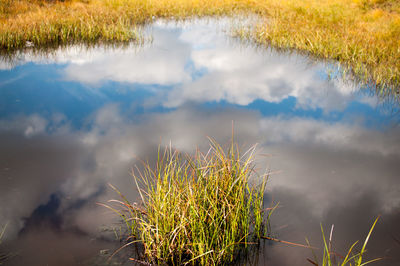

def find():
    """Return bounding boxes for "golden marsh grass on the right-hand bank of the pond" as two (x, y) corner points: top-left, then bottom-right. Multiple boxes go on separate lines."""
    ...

(250, 0), (400, 92)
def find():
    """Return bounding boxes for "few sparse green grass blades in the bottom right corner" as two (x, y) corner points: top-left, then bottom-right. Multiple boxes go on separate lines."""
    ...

(307, 216), (381, 266)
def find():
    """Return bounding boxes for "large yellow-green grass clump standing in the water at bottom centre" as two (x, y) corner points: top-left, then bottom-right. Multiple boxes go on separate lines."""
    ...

(104, 141), (267, 265)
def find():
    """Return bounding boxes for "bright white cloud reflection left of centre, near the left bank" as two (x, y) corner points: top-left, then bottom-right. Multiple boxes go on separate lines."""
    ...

(64, 29), (194, 85)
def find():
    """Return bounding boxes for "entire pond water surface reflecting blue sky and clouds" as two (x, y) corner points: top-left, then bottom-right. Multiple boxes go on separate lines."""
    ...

(0, 21), (400, 265)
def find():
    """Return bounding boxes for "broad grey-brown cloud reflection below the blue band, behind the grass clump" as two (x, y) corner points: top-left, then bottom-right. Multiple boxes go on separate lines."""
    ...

(0, 105), (400, 264)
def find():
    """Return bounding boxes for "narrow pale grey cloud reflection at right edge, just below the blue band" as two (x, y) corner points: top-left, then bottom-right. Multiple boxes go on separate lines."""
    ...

(260, 117), (400, 156)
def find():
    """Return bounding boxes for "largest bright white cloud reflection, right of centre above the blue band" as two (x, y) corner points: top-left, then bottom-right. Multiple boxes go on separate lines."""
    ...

(163, 29), (354, 111)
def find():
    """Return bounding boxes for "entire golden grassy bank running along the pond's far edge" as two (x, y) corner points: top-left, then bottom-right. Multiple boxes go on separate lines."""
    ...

(0, 0), (400, 90)
